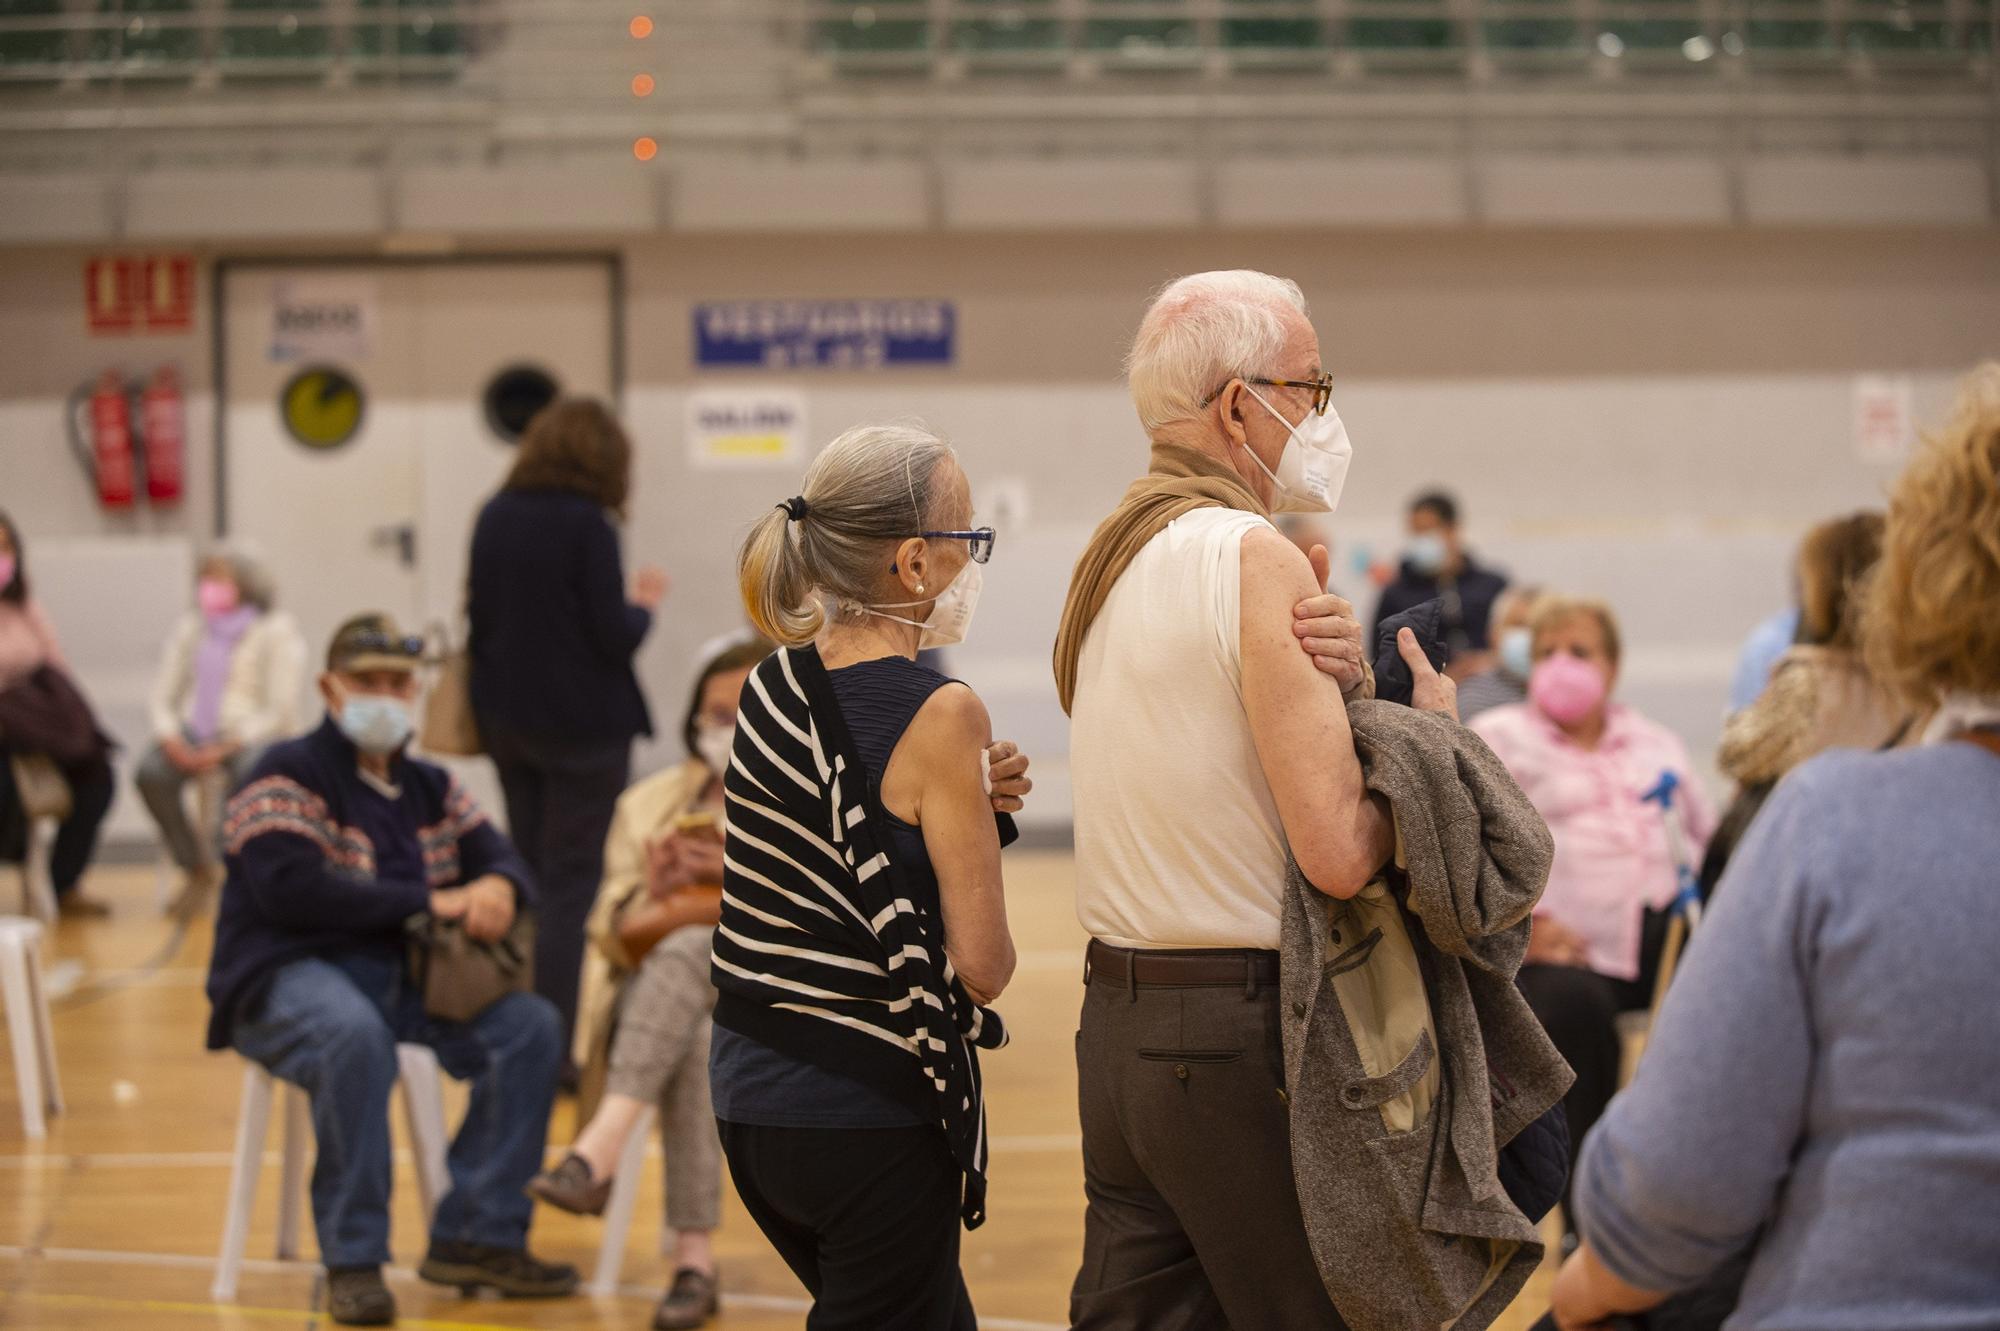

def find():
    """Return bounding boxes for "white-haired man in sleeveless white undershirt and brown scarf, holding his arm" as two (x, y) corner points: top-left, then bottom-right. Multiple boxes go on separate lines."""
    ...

(1056, 272), (1452, 1331)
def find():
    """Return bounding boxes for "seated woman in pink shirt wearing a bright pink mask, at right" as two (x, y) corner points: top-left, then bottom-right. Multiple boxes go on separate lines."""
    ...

(1472, 598), (1716, 1215)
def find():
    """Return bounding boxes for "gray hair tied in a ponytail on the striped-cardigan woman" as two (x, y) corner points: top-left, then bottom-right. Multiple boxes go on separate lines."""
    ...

(736, 415), (952, 648)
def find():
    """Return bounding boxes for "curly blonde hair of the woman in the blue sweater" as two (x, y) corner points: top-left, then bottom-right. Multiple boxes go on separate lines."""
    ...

(1862, 362), (2000, 707)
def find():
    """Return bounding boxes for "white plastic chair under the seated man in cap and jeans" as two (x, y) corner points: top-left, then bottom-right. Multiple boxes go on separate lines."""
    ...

(210, 1045), (450, 1303)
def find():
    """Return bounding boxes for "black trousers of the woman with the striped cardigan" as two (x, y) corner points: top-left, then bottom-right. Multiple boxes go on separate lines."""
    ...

(716, 1119), (978, 1331)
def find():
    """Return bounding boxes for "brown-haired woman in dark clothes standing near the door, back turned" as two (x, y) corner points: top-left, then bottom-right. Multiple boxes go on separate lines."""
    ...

(466, 398), (666, 1047)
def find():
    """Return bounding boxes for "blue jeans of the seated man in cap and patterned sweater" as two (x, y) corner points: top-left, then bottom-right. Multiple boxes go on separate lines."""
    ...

(236, 951), (562, 1267)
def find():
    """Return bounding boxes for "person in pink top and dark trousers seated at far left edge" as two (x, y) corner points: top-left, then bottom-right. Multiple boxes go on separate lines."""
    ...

(0, 514), (114, 917)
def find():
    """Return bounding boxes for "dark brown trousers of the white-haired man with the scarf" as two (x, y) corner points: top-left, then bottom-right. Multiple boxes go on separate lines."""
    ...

(1070, 947), (1344, 1331)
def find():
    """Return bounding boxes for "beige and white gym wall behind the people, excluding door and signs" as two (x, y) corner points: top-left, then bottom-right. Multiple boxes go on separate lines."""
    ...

(0, 230), (2000, 839)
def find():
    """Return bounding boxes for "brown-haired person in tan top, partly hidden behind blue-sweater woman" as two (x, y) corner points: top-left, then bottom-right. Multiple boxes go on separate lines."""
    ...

(1702, 514), (1916, 895)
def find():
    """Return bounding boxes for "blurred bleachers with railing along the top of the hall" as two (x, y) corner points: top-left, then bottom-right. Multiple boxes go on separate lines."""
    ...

(0, 0), (2000, 170)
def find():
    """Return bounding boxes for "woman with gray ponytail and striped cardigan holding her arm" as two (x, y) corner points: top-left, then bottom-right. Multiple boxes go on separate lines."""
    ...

(710, 426), (1028, 1331)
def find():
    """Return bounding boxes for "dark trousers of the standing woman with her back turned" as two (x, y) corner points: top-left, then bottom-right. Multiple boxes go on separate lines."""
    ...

(480, 717), (632, 1051)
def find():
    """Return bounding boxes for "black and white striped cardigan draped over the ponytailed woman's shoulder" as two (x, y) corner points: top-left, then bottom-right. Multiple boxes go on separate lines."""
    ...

(710, 648), (1014, 1229)
